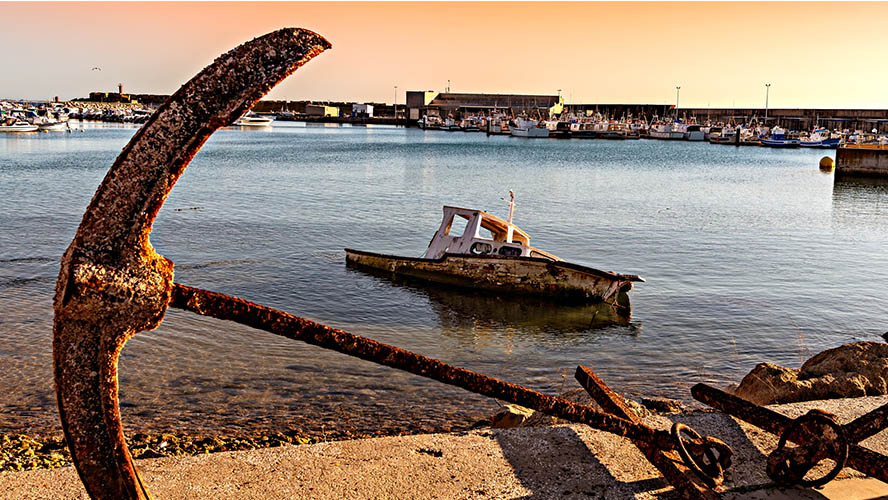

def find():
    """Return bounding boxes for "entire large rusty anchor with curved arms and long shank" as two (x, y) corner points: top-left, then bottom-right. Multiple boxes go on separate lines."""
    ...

(53, 29), (730, 500)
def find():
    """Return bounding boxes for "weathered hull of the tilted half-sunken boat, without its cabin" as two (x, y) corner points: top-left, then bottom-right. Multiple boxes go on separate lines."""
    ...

(345, 248), (641, 308)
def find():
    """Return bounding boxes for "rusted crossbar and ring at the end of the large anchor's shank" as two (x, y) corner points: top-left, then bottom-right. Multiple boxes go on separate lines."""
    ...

(575, 366), (732, 500)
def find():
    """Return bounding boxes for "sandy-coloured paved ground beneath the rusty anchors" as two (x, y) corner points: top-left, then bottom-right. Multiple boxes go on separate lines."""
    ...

(0, 396), (888, 500)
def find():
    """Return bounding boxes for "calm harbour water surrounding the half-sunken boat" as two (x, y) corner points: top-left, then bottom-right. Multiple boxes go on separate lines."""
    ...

(0, 124), (888, 438)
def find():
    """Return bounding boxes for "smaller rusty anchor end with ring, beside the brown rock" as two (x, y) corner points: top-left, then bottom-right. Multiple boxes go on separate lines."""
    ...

(691, 384), (888, 487)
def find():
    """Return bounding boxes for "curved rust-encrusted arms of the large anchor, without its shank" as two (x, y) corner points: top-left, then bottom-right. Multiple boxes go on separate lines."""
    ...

(53, 29), (330, 500)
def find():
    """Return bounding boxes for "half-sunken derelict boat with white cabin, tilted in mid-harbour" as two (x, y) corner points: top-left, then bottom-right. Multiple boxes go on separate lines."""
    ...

(345, 193), (644, 308)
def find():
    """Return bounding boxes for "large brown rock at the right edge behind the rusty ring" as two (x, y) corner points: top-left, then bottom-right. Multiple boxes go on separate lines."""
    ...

(735, 342), (888, 404)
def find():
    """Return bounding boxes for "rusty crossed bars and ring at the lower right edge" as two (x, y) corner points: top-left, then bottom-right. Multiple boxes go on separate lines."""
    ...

(691, 384), (888, 484)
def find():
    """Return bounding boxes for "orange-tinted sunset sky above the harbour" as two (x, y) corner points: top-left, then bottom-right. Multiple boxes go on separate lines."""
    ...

(0, 2), (888, 108)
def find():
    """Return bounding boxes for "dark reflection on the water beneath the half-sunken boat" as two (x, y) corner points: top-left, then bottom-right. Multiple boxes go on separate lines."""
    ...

(348, 264), (635, 335)
